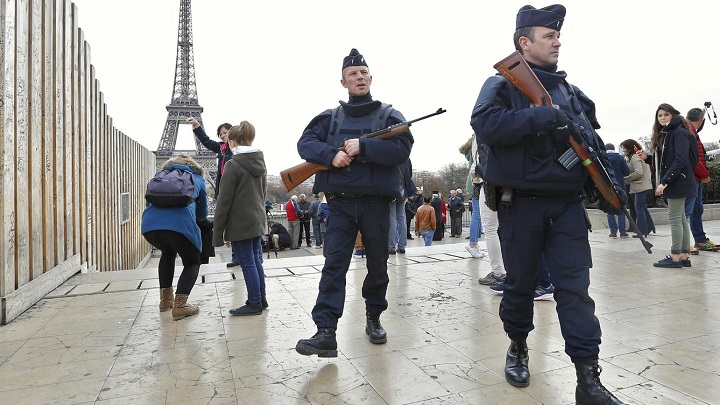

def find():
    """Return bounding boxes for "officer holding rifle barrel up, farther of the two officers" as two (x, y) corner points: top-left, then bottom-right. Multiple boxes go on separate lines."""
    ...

(295, 49), (413, 357)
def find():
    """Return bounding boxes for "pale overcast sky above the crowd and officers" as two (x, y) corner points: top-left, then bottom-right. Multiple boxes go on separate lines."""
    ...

(69, 0), (720, 174)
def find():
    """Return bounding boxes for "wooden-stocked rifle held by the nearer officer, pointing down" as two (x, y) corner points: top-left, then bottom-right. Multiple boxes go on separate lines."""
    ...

(493, 51), (653, 253)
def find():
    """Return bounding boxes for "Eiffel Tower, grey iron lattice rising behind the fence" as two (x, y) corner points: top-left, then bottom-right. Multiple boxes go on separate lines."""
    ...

(155, 0), (217, 190)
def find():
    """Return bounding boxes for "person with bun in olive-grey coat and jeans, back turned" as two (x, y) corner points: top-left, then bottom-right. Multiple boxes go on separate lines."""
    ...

(213, 121), (268, 316)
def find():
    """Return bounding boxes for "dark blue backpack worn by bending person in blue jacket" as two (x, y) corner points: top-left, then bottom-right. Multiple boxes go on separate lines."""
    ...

(145, 169), (195, 207)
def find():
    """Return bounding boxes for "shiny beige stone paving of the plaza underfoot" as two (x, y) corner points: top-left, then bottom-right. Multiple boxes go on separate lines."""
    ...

(0, 221), (720, 405)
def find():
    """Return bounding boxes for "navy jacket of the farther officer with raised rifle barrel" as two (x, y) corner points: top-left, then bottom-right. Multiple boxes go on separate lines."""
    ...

(297, 93), (413, 198)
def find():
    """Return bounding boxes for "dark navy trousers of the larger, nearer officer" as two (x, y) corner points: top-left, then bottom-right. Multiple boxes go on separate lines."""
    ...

(498, 194), (601, 359)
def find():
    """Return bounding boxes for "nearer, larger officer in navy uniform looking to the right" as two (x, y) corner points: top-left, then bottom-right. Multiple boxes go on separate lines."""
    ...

(470, 4), (625, 404)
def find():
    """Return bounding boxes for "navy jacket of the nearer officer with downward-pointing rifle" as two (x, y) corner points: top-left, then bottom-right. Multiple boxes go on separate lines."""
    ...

(470, 67), (614, 192)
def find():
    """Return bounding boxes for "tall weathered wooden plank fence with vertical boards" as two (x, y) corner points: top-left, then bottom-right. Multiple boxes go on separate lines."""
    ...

(0, 0), (155, 324)
